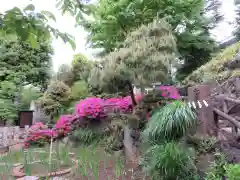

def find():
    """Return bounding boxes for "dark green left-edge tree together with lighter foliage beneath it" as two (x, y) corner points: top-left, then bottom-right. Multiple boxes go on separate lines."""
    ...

(0, 40), (53, 121)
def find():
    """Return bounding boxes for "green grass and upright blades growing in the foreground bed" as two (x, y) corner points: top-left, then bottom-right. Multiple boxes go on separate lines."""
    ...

(0, 143), (127, 179)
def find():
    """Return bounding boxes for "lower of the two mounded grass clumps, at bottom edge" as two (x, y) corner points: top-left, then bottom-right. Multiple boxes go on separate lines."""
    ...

(142, 142), (197, 180)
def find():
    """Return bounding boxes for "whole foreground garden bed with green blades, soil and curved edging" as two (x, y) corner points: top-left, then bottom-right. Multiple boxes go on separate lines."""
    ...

(0, 144), (146, 180)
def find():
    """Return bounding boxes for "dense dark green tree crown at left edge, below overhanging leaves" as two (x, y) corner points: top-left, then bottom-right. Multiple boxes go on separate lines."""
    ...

(0, 40), (53, 89)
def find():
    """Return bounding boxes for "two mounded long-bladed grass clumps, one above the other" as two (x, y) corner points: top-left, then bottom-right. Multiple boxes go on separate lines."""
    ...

(141, 101), (198, 180)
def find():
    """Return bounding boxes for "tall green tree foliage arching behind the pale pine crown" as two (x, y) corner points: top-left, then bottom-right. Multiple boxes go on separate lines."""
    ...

(68, 0), (222, 79)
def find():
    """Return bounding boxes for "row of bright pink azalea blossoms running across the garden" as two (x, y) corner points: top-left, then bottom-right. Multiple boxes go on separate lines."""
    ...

(25, 90), (180, 147)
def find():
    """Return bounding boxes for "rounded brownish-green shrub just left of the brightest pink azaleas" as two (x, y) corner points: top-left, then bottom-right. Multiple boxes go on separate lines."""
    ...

(38, 81), (71, 120)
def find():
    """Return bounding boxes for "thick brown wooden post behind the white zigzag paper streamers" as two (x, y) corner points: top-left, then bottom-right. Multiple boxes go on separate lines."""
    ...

(188, 85), (218, 137)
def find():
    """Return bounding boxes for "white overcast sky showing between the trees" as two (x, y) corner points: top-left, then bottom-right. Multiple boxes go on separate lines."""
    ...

(0, 0), (235, 71)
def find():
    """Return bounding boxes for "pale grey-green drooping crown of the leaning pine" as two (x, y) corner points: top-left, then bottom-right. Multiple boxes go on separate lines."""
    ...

(90, 20), (176, 93)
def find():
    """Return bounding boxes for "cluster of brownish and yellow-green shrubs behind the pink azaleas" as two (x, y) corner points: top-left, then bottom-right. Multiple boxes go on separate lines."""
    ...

(38, 54), (92, 121)
